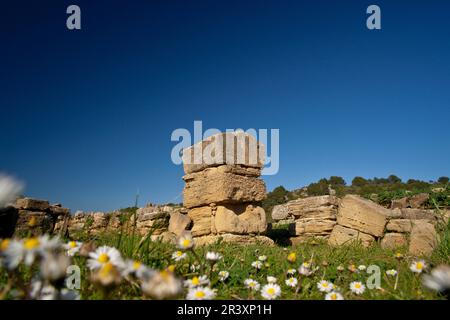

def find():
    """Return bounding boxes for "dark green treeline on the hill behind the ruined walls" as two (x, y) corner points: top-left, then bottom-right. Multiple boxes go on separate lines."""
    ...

(263, 175), (450, 212)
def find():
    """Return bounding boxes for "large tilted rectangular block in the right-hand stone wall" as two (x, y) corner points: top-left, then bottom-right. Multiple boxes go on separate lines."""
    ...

(337, 195), (389, 237)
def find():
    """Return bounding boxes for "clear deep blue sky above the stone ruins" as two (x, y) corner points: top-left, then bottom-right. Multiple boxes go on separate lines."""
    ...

(0, 0), (450, 210)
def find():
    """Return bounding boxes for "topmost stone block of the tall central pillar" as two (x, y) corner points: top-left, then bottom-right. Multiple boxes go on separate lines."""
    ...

(182, 132), (265, 174)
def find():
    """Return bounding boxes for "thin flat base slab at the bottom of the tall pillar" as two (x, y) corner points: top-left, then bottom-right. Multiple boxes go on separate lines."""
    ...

(195, 234), (275, 246)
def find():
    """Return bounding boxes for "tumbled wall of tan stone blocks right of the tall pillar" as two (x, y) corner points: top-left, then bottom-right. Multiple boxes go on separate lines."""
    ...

(272, 195), (450, 255)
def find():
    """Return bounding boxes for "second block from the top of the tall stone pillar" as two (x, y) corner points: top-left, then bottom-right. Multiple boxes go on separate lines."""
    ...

(183, 167), (266, 208)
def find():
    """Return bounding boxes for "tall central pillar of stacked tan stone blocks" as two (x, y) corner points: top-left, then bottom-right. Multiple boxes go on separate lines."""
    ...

(169, 132), (273, 245)
